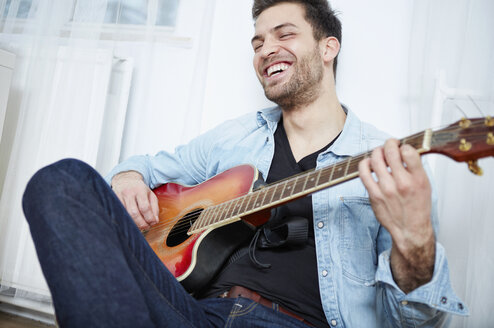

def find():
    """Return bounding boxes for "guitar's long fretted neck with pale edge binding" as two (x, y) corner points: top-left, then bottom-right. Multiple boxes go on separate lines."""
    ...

(188, 129), (432, 234)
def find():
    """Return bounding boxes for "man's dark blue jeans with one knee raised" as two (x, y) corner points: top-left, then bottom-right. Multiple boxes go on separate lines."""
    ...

(22, 159), (307, 328)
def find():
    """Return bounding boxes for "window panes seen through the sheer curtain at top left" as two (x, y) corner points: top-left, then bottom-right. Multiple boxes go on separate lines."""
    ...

(0, 0), (180, 27)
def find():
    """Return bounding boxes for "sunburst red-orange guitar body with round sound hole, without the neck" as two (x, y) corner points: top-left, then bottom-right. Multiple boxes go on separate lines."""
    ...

(145, 165), (269, 292)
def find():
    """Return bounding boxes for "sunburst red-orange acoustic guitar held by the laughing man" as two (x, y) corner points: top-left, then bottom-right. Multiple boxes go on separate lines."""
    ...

(144, 116), (494, 292)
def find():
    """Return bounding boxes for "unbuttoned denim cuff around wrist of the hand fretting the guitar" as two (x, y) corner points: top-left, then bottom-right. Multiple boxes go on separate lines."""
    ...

(376, 242), (469, 316)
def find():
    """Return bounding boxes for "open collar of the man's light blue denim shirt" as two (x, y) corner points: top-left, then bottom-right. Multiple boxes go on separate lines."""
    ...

(257, 105), (364, 156)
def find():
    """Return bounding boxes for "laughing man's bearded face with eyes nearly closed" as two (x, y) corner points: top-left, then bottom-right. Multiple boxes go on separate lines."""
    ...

(252, 3), (324, 109)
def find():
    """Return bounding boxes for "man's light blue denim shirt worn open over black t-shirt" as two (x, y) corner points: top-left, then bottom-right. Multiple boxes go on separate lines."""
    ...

(106, 107), (468, 328)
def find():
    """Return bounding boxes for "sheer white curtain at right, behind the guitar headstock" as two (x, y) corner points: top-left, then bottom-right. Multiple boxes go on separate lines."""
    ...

(409, 0), (494, 327)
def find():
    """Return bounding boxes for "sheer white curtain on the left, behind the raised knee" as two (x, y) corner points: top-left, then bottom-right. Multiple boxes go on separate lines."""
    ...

(0, 0), (214, 320)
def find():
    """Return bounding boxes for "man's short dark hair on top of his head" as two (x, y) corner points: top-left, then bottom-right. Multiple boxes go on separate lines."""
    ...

(252, 0), (341, 76)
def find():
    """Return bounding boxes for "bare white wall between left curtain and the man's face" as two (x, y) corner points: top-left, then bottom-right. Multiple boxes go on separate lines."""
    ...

(201, 0), (271, 131)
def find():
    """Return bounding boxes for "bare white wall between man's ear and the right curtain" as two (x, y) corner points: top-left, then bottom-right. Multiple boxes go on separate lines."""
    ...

(331, 0), (415, 137)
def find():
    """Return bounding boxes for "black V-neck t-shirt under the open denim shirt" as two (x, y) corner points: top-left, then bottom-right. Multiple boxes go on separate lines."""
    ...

(206, 121), (334, 327)
